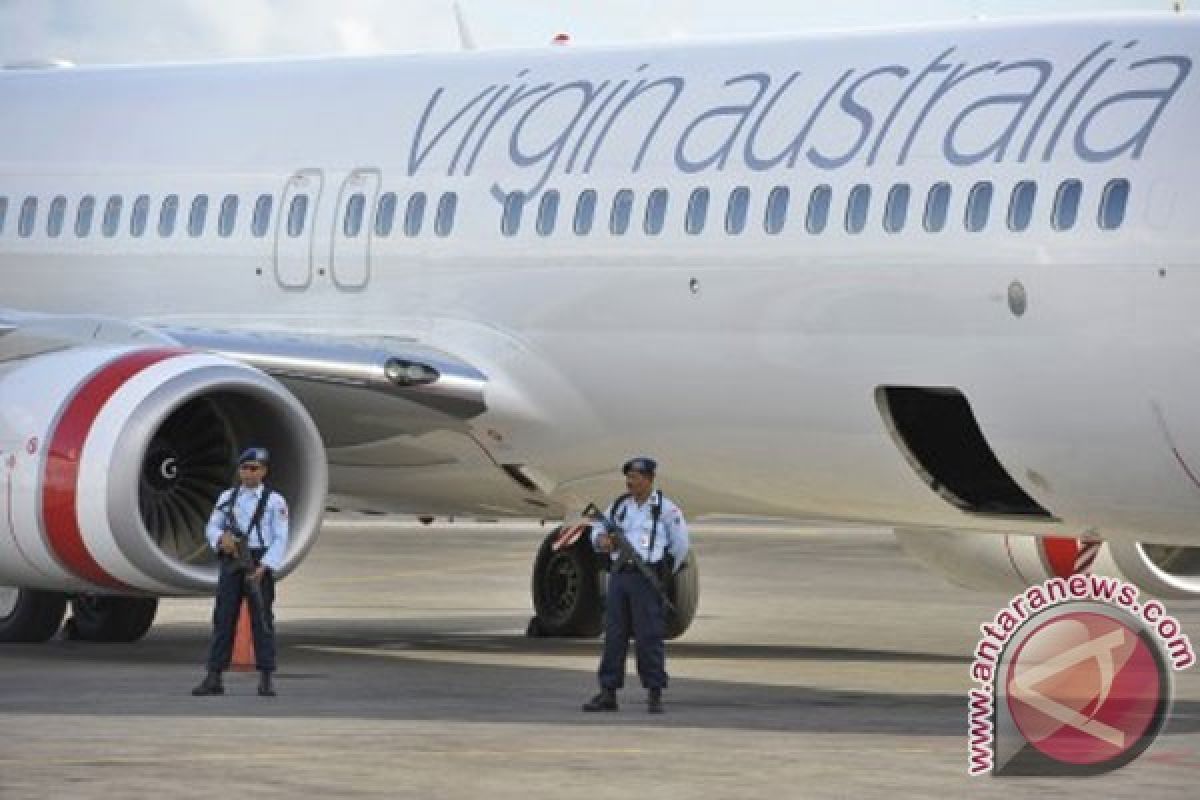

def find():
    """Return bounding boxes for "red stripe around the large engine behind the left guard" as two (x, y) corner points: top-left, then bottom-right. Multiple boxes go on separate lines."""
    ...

(42, 349), (184, 589)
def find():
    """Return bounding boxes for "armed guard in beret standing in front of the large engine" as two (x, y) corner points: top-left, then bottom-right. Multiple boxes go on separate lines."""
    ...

(192, 447), (288, 697)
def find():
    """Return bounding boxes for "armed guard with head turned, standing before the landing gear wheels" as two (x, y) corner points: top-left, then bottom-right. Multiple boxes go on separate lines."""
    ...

(583, 457), (688, 714)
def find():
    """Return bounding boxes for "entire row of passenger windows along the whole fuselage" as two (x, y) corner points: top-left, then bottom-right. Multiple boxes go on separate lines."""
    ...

(0, 179), (1129, 244)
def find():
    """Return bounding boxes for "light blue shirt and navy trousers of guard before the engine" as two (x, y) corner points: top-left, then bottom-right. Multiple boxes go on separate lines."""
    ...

(204, 485), (288, 673)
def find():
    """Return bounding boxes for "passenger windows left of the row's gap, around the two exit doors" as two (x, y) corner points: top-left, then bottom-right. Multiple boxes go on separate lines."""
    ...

(0, 192), (458, 239)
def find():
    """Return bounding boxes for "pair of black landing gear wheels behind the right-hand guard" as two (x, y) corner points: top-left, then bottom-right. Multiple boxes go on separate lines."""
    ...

(526, 528), (700, 639)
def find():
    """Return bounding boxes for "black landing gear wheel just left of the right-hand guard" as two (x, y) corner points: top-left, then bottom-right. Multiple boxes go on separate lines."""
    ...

(526, 525), (605, 637)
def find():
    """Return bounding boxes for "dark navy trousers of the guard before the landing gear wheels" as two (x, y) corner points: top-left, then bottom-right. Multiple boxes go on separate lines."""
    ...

(599, 572), (667, 690)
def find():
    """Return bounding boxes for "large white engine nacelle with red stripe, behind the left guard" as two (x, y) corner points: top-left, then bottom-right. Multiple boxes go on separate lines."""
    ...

(0, 347), (328, 595)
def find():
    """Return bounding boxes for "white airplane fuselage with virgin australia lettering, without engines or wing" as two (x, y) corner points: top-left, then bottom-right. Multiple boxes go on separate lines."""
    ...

(0, 14), (1200, 543)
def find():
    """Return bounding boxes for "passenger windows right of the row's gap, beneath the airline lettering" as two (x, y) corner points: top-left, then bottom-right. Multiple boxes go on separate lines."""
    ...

(500, 179), (1129, 236)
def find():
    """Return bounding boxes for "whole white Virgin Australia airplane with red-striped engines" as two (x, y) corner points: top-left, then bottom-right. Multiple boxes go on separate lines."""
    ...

(0, 13), (1200, 642)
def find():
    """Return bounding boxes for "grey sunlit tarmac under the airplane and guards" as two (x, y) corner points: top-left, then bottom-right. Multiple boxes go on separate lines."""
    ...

(0, 518), (1200, 800)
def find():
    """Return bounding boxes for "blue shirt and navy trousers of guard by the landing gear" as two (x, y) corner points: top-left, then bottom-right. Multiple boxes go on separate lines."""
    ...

(592, 491), (689, 691)
